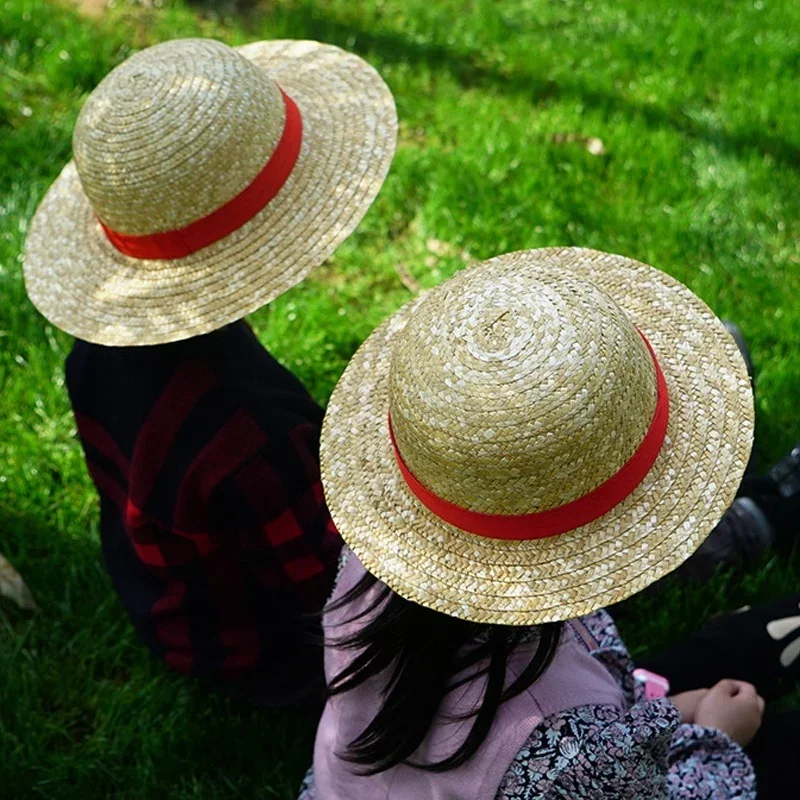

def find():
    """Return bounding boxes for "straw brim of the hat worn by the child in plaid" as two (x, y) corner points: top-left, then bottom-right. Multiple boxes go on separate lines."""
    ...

(24, 40), (397, 345)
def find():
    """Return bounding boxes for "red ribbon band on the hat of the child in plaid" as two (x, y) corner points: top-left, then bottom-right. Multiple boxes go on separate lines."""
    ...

(100, 89), (303, 260)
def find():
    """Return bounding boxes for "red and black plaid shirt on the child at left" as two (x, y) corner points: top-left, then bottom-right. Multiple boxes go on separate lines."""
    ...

(67, 322), (341, 695)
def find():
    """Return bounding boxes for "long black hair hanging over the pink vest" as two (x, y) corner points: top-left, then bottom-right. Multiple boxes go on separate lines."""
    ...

(328, 573), (563, 775)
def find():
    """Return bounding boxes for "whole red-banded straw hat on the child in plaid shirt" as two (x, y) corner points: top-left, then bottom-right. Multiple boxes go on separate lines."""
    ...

(24, 39), (397, 345)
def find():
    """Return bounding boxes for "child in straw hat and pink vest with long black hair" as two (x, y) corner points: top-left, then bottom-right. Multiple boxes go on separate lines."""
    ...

(300, 248), (800, 800)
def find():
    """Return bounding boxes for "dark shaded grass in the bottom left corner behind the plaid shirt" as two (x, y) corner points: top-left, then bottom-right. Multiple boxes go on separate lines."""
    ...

(0, 507), (316, 800)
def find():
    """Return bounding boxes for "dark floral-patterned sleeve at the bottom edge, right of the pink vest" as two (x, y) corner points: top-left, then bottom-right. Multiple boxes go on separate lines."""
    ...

(496, 700), (756, 800)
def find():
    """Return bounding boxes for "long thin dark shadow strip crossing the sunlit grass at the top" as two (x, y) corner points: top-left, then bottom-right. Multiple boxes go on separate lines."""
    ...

(219, 0), (800, 168)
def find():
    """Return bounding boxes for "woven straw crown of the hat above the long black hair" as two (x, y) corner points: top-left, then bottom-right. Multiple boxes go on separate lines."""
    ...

(390, 270), (657, 514)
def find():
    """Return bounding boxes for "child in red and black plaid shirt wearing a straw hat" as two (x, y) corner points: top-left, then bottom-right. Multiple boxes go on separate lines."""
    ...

(24, 39), (397, 705)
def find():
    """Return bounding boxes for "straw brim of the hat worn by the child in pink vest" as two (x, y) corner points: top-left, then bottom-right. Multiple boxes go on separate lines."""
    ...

(321, 248), (754, 625)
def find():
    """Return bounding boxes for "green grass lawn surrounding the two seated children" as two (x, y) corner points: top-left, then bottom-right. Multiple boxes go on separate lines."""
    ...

(0, 0), (800, 800)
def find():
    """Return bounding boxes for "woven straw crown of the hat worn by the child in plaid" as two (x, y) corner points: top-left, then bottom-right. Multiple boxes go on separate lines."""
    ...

(72, 39), (285, 235)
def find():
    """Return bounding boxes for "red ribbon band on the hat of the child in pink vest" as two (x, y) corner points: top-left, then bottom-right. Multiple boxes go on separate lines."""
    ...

(389, 331), (669, 541)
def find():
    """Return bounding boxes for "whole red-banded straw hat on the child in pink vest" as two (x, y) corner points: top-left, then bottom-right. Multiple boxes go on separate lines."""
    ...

(322, 248), (753, 625)
